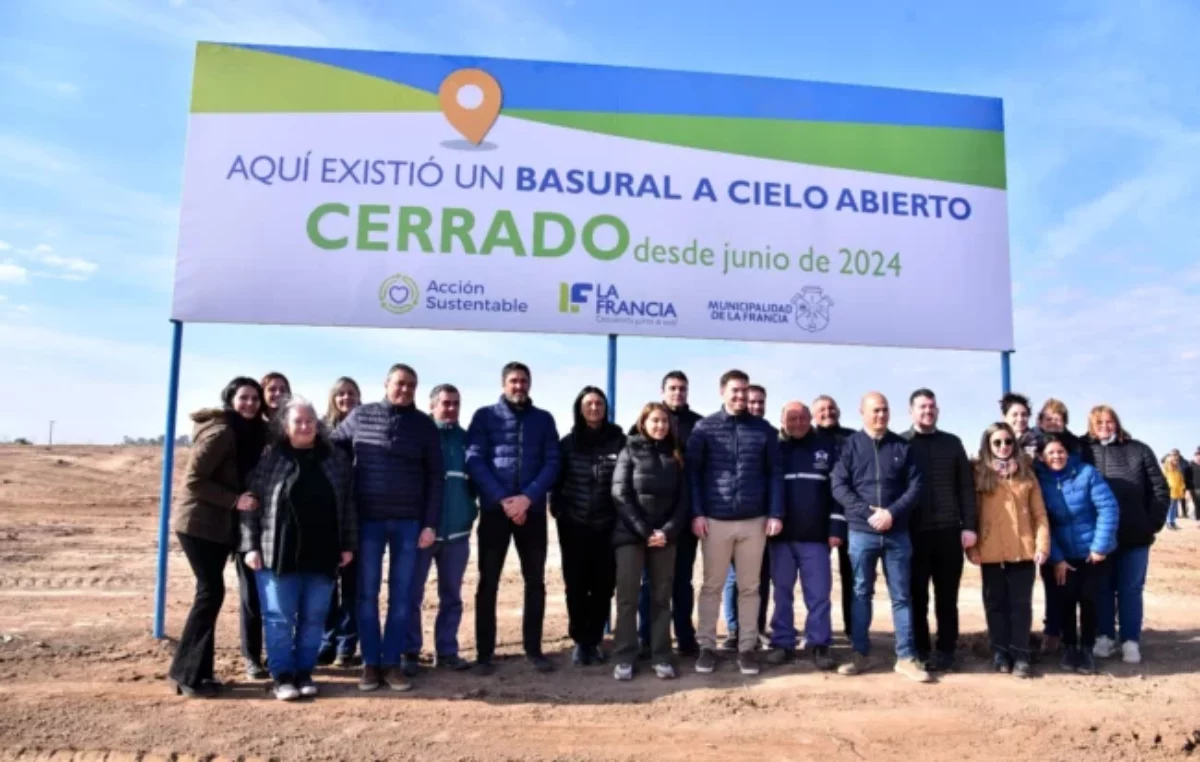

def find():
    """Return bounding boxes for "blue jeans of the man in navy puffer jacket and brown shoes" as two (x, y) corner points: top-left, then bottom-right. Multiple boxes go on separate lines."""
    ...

(359, 520), (421, 667)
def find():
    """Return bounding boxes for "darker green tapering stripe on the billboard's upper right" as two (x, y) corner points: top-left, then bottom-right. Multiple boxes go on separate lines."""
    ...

(504, 109), (1006, 190)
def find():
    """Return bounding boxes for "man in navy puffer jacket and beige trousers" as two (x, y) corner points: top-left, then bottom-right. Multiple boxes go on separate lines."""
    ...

(685, 371), (784, 674)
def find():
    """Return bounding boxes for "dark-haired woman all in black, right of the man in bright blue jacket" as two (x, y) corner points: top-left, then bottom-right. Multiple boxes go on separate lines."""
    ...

(550, 386), (625, 666)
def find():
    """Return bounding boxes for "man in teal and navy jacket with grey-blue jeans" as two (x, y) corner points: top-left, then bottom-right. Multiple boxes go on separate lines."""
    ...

(400, 384), (479, 677)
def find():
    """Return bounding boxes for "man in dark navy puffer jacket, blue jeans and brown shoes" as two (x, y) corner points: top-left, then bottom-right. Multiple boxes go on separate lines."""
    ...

(330, 364), (445, 691)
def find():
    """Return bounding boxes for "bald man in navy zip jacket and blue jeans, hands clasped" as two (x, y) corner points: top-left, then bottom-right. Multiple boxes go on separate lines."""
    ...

(833, 391), (930, 683)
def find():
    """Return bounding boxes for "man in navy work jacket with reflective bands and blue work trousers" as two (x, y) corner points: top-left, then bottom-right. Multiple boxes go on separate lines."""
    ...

(767, 402), (846, 670)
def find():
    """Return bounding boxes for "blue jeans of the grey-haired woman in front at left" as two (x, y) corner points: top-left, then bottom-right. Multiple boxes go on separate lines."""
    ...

(254, 569), (334, 679)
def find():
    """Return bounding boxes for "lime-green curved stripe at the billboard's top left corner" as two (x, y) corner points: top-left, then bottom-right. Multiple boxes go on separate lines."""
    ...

(192, 43), (442, 114)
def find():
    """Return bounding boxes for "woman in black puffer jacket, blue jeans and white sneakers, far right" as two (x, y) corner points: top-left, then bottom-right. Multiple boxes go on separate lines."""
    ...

(1084, 404), (1171, 664)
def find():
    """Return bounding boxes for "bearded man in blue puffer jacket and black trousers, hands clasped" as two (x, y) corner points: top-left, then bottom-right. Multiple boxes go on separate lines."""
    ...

(467, 362), (559, 674)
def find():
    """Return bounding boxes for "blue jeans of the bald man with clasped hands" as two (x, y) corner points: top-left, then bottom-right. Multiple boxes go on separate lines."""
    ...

(850, 529), (917, 659)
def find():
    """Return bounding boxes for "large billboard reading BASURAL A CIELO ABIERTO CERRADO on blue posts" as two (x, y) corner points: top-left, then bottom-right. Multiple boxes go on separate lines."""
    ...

(173, 43), (1013, 350)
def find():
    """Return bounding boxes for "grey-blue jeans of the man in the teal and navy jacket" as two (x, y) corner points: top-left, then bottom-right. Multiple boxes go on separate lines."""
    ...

(404, 538), (470, 656)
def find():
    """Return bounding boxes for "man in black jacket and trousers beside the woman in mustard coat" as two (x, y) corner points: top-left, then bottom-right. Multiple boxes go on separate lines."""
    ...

(901, 389), (978, 672)
